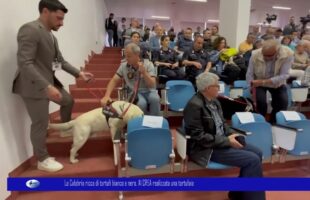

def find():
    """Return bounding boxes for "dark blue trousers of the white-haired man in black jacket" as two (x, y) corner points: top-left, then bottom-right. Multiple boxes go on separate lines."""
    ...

(211, 144), (265, 200)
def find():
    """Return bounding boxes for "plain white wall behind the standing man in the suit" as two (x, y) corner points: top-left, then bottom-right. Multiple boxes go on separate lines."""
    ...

(0, 0), (107, 199)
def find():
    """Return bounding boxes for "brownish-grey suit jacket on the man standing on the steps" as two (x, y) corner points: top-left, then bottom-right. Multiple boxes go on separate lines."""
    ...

(13, 20), (79, 98)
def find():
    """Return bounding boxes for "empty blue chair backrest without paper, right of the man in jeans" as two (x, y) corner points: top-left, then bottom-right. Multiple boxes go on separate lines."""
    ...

(166, 80), (195, 111)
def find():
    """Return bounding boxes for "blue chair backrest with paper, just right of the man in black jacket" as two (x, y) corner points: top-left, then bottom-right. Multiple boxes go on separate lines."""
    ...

(232, 113), (273, 159)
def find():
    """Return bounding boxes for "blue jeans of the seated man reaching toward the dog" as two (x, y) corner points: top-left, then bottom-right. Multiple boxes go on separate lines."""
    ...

(137, 90), (160, 116)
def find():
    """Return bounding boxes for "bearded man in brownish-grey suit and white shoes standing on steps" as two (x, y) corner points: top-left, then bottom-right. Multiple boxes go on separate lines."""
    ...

(13, 0), (93, 172)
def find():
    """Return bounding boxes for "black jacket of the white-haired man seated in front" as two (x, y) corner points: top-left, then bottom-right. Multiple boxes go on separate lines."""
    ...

(184, 92), (233, 167)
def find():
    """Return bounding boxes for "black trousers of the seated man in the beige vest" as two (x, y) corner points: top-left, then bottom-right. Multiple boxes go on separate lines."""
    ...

(256, 85), (288, 123)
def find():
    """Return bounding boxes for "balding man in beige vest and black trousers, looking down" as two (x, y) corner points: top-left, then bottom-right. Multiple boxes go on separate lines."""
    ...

(246, 39), (294, 123)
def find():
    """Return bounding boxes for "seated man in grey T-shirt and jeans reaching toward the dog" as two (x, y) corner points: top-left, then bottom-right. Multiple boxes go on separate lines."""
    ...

(101, 43), (160, 115)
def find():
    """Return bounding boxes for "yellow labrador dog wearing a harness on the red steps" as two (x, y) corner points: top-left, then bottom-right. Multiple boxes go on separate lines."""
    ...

(49, 101), (143, 164)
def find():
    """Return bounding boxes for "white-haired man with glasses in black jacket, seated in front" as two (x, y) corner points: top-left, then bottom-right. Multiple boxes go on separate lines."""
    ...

(184, 73), (265, 200)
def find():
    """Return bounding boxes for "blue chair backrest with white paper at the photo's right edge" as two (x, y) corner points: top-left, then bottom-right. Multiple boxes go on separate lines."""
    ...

(276, 111), (310, 155)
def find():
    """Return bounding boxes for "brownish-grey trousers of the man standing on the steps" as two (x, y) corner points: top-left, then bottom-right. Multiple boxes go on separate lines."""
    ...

(22, 88), (74, 161)
